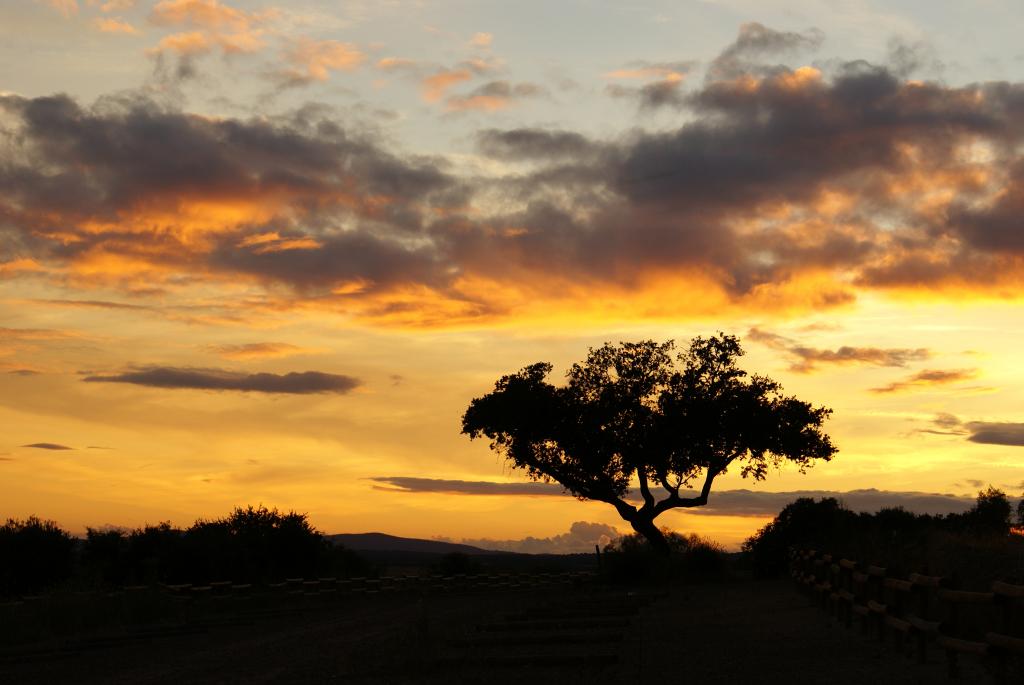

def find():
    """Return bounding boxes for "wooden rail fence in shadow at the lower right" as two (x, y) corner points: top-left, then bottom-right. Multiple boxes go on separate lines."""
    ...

(790, 549), (1024, 683)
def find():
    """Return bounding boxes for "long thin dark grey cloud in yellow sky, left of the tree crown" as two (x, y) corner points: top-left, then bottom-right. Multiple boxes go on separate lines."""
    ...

(82, 367), (360, 394)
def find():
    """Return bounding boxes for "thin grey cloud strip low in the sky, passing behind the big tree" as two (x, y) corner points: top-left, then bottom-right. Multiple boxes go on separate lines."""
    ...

(371, 476), (974, 516)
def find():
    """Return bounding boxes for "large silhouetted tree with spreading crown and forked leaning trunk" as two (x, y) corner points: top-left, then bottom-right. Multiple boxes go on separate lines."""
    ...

(462, 335), (836, 554)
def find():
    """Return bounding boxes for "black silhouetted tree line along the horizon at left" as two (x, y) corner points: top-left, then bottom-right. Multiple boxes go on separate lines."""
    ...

(0, 506), (369, 596)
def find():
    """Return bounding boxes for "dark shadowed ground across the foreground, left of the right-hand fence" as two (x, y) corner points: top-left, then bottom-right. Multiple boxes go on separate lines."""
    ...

(0, 581), (986, 685)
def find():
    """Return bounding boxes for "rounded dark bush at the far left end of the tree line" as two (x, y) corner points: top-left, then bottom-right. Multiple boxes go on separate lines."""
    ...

(0, 516), (76, 596)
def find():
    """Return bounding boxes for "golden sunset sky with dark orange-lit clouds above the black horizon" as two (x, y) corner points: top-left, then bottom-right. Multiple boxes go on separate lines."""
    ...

(0, 0), (1024, 551)
